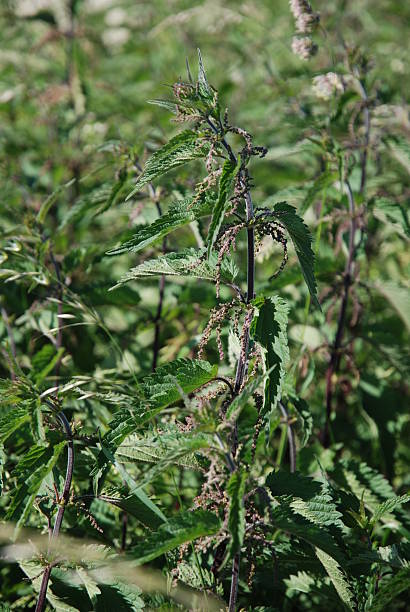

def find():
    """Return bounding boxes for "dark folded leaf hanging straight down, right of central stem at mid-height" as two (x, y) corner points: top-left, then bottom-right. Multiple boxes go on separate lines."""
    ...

(251, 296), (289, 424)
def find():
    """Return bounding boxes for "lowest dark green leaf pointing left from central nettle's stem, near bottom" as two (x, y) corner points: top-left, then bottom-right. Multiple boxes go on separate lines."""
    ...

(130, 510), (220, 565)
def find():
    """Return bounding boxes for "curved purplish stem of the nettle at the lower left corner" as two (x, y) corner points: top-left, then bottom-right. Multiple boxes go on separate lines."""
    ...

(36, 410), (74, 612)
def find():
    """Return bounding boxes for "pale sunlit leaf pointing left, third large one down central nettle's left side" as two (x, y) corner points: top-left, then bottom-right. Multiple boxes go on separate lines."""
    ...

(110, 248), (237, 291)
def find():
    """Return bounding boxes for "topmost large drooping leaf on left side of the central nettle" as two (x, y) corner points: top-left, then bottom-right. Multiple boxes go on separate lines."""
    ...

(126, 130), (210, 200)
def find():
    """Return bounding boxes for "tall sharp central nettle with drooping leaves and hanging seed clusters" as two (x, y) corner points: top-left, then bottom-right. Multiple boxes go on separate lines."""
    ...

(110, 51), (320, 610)
